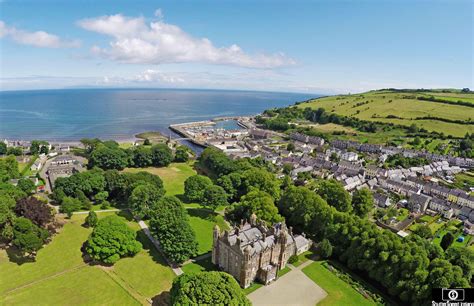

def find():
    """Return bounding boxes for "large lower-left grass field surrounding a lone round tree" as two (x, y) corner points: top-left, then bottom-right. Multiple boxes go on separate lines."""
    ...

(0, 213), (174, 305)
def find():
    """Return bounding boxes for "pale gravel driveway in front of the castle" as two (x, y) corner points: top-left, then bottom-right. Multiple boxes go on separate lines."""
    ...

(247, 265), (327, 306)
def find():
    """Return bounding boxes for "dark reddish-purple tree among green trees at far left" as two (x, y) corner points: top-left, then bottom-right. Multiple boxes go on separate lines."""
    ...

(15, 197), (53, 227)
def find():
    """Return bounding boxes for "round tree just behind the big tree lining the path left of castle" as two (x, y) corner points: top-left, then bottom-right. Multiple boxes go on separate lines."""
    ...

(128, 183), (164, 219)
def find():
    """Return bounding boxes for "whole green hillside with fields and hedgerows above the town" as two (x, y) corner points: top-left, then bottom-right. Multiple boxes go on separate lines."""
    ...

(298, 90), (474, 137)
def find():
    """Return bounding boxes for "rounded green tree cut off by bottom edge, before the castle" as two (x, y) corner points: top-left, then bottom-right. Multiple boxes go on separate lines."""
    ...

(170, 271), (251, 306)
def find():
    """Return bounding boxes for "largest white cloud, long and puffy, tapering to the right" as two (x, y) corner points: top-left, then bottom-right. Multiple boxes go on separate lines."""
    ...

(78, 14), (295, 68)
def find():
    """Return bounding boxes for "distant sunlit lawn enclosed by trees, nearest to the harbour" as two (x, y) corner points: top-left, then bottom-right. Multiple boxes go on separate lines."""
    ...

(124, 163), (196, 195)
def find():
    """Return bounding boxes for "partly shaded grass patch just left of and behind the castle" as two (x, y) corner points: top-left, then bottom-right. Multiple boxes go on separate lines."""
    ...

(188, 208), (229, 255)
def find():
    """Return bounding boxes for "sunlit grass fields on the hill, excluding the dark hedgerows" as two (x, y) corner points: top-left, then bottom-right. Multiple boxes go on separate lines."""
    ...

(298, 91), (474, 137)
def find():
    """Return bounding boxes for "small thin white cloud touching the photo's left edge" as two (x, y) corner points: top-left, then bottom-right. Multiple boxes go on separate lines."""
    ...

(0, 20), (80, 48)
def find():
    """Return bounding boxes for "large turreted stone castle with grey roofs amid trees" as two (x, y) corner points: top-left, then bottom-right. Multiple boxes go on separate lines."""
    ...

(212, 214), (311, 288)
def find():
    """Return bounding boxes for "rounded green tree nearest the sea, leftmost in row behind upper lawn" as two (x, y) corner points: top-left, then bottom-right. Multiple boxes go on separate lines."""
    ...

(87, 144), (128, 170)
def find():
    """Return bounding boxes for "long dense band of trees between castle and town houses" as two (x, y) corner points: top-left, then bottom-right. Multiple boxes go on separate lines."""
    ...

(278, 183), (472, 304)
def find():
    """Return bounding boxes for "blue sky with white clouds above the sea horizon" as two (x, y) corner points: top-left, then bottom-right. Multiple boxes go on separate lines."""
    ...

(0, 0), (474, 94)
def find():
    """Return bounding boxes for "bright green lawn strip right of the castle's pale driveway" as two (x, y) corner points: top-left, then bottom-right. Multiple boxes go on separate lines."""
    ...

(303, 261), (376, 306)
